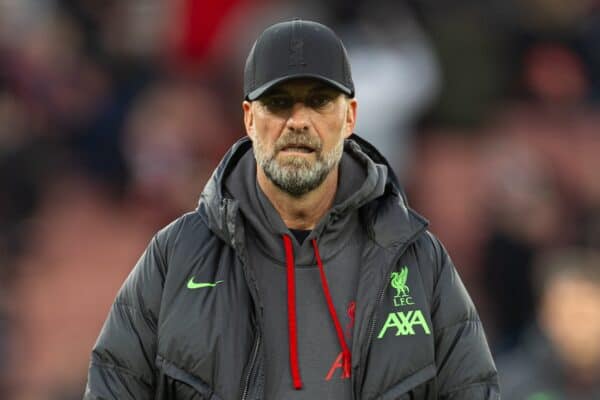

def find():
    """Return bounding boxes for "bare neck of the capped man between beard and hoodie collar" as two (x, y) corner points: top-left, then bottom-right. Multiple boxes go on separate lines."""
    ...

(257, 167), (338, 230)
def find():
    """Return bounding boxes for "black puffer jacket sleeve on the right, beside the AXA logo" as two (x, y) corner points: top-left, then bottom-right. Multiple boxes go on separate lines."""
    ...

(431, 236), (500, 400)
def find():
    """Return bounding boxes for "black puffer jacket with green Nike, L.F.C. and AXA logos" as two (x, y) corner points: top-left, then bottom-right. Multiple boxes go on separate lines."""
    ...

(84, 136), (500, 400)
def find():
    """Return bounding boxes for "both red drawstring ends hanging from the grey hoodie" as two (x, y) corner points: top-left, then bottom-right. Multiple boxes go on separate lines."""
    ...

(283, 235), (352, 390)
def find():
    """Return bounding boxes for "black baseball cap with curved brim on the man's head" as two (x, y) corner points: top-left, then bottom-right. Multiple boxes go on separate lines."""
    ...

(244, 19), (354, 101)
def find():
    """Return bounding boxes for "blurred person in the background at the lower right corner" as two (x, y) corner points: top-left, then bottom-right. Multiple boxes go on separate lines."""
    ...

(498, 249), (600, 400)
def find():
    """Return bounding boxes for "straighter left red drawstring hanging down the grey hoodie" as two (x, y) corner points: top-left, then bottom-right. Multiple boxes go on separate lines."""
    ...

(283, 235), (302, 390)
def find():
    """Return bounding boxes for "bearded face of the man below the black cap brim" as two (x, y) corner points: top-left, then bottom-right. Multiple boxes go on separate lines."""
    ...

(243, 79), (356, 197)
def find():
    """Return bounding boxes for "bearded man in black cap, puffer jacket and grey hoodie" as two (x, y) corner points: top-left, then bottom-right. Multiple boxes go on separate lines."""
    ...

(85, 20), (499, 400)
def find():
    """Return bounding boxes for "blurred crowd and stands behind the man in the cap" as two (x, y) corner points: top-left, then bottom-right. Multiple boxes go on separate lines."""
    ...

(0, 0), (600, 400)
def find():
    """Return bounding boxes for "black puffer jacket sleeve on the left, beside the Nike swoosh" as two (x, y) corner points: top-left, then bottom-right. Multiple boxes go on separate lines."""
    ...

(83, 235), (166, 400)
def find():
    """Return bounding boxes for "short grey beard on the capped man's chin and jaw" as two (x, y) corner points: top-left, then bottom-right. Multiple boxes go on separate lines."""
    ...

(254, 136), (344, 197)
